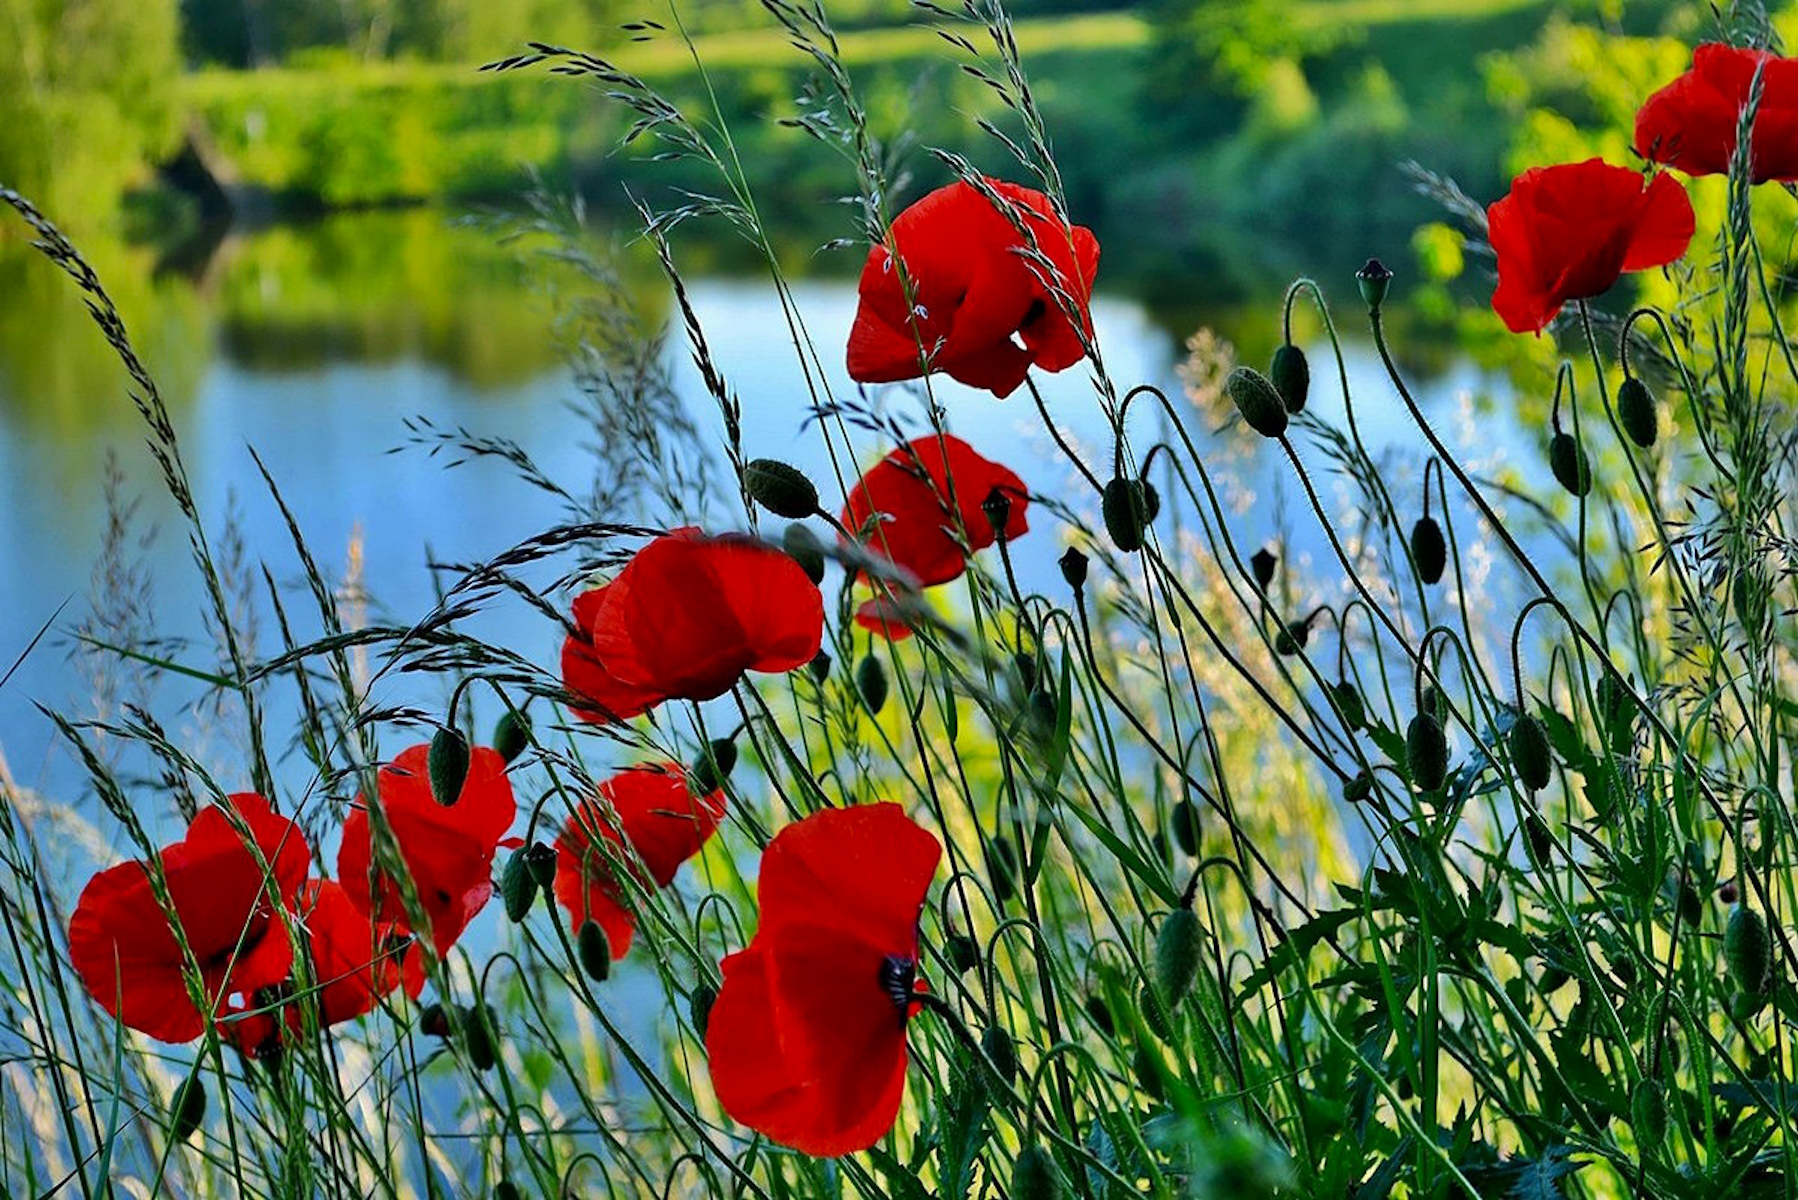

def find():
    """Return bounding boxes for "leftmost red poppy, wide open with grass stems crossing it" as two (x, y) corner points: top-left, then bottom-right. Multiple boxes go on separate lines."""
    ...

(68, 792), (307, 1042)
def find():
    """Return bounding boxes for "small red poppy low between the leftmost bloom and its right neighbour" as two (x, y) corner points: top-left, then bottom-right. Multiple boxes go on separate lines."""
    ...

(225, 880), (399, 1056)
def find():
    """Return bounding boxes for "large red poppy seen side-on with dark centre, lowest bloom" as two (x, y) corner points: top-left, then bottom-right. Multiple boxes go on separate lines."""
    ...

(705, 804), (942, 1155)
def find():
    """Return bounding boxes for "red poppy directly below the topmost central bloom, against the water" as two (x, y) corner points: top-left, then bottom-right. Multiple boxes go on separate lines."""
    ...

(841, 434), (1030, 588)
